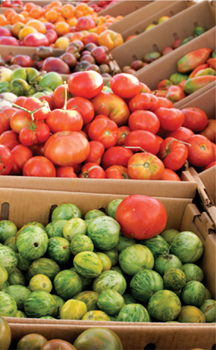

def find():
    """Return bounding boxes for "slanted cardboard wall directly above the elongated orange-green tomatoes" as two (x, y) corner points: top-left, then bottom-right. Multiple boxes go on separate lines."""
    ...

(135, 23), (216, 90)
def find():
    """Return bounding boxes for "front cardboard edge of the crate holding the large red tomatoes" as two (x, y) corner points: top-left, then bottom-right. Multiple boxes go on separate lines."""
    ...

(0, 176), (197, 198)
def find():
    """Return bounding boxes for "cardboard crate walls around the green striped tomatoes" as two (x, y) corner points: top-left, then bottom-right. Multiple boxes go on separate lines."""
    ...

(0, 188), (216, 350)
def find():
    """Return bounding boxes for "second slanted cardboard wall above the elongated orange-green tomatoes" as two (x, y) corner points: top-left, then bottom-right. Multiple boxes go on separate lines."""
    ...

(111, 1), (216, 69)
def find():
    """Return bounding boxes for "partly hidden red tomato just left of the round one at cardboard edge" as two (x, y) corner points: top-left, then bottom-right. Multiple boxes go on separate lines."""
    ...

(10, 145), (33, 175)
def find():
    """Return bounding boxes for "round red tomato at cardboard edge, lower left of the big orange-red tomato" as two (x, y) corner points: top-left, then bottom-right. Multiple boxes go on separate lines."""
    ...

(23, 156), (56, 177)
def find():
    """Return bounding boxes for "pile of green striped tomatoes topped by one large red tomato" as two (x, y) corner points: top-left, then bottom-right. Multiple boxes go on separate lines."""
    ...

(0, 195), (216, 323)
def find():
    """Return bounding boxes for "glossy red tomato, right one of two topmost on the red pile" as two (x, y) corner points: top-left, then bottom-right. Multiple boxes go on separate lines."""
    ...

(110, 73), (141, 98)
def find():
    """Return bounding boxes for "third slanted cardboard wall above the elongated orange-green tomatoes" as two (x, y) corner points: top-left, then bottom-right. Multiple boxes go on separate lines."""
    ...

(109, 0), (194, 40)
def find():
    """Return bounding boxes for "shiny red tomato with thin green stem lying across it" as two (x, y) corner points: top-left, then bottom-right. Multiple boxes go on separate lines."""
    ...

(23, 97), (50, 120)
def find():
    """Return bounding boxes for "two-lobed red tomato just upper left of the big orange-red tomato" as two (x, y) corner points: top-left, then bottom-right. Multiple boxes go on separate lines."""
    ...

(19, 121), (50, 146)
